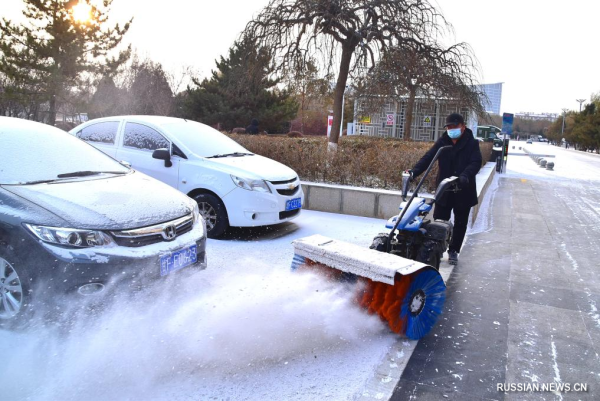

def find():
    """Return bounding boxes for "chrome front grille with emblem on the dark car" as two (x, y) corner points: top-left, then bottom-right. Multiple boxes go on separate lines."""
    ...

(111, 214), (194, 247)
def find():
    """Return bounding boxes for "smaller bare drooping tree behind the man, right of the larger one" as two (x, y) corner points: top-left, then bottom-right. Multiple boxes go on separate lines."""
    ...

(358, 43), (485, 140)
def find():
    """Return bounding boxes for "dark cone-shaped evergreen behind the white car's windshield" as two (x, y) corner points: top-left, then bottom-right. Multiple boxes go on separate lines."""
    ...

(180, 41), (298, 133)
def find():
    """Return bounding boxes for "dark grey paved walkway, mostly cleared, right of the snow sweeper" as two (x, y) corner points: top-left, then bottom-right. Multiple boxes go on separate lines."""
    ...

(391, 173), (600, 400)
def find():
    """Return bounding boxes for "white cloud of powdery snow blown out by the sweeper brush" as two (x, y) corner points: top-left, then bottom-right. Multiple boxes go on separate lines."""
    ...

(0, 258), (387, 400)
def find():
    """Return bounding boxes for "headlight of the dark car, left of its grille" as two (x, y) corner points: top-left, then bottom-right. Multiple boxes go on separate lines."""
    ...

(24, 224), (114, 248)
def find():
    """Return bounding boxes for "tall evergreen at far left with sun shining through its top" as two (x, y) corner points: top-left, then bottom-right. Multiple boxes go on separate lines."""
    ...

(0, 0), (131, 125)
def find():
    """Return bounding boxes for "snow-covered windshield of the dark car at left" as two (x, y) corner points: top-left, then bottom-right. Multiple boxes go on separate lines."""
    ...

(0, 117), (130, 185)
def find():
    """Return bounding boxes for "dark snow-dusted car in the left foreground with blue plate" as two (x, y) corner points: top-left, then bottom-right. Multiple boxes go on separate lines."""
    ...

(0, 117), (206, 321)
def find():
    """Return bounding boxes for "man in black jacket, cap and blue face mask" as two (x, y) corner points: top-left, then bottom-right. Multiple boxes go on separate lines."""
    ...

(410, 113), (481, 265)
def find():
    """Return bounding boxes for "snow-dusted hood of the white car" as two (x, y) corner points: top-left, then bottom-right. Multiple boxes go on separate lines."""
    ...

(206, 154), (298, 181)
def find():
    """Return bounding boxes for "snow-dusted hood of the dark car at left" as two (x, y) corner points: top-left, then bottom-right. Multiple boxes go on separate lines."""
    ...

(3, 171), (193, 230)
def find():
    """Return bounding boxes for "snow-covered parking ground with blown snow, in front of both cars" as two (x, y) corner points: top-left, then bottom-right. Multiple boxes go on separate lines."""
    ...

(0, 211), (424, 400)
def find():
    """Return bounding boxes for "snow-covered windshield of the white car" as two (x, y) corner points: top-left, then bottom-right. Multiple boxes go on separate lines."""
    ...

(162, 120), (252, 157)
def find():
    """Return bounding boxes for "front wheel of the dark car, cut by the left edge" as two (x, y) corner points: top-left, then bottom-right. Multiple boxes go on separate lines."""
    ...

(0, 255), (29, 323)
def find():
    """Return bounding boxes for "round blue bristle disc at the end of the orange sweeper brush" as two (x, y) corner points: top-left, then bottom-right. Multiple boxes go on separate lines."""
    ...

(400, 269), (446, 340)
